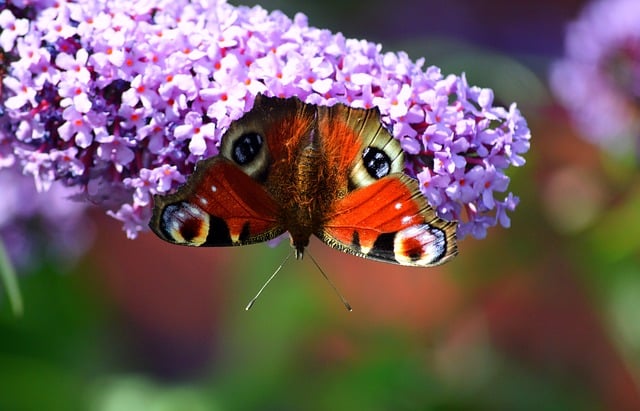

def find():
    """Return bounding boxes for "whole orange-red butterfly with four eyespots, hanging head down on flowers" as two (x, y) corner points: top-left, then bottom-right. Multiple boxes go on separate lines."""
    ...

(149, 95), (457, 267)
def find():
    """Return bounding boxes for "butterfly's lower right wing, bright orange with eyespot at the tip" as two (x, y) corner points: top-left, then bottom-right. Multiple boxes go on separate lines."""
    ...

(318, 174), (457, 267)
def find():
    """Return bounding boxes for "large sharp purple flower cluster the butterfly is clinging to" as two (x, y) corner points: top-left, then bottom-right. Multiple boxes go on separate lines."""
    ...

(0, 0), (530, 238)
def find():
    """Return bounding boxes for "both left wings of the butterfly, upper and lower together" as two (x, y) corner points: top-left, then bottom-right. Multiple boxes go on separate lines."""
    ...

(149, 96), (315, 246)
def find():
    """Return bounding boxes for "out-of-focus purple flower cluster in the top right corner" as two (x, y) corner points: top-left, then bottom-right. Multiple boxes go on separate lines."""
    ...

(550, 0), (640, 152)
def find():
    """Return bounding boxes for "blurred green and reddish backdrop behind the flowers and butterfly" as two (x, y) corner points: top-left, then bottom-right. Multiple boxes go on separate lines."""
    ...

(0, 0), (640, 411)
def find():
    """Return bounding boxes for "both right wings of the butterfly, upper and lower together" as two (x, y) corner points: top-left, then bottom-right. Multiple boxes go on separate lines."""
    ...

(316, 105), (457, 267)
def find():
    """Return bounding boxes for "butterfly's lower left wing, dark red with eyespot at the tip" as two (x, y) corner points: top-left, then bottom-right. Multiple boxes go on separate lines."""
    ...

(150, 157), (284, 246)
